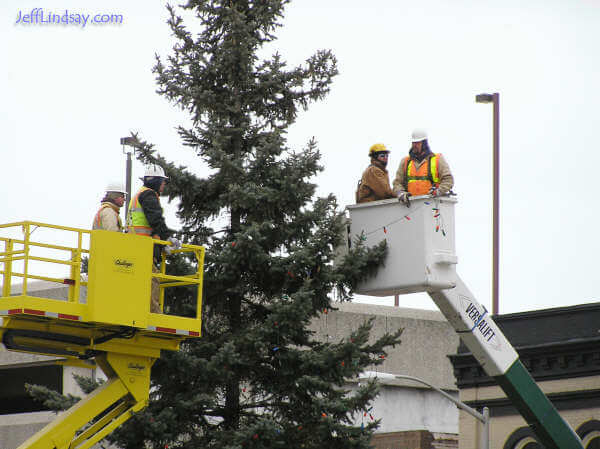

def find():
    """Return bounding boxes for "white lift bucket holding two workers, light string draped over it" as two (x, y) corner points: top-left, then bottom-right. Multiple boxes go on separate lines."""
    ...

(347, 195), (457, 296)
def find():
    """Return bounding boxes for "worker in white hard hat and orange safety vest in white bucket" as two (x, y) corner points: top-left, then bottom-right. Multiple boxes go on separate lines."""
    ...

(393, 129), (454, 206)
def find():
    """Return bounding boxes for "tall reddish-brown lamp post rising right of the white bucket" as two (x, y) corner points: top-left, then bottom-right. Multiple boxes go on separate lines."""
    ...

(475, 92), (500, 315)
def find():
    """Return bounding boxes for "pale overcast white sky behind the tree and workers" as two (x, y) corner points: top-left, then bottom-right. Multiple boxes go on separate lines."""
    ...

(0, 0), (600, 313)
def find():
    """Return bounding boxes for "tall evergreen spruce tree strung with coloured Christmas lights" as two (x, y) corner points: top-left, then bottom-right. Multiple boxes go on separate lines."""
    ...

(114, 0), (399, 449)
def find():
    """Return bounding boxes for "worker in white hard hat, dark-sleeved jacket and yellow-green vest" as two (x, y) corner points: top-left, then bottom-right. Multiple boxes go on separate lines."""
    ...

(127, 164), (181, 313)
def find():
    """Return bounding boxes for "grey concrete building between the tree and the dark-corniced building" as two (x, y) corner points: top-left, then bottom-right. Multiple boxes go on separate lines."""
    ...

(312, 303), (459, 449)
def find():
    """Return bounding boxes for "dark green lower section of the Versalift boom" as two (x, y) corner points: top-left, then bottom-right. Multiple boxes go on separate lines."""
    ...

(495, 360), (583, 449)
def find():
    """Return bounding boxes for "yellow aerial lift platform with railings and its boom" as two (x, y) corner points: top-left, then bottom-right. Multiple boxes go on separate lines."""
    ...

(0, 221), (204, 449)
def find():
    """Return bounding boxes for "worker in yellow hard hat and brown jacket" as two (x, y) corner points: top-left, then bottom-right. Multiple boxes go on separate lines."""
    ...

(356, 143), (396, 203)
